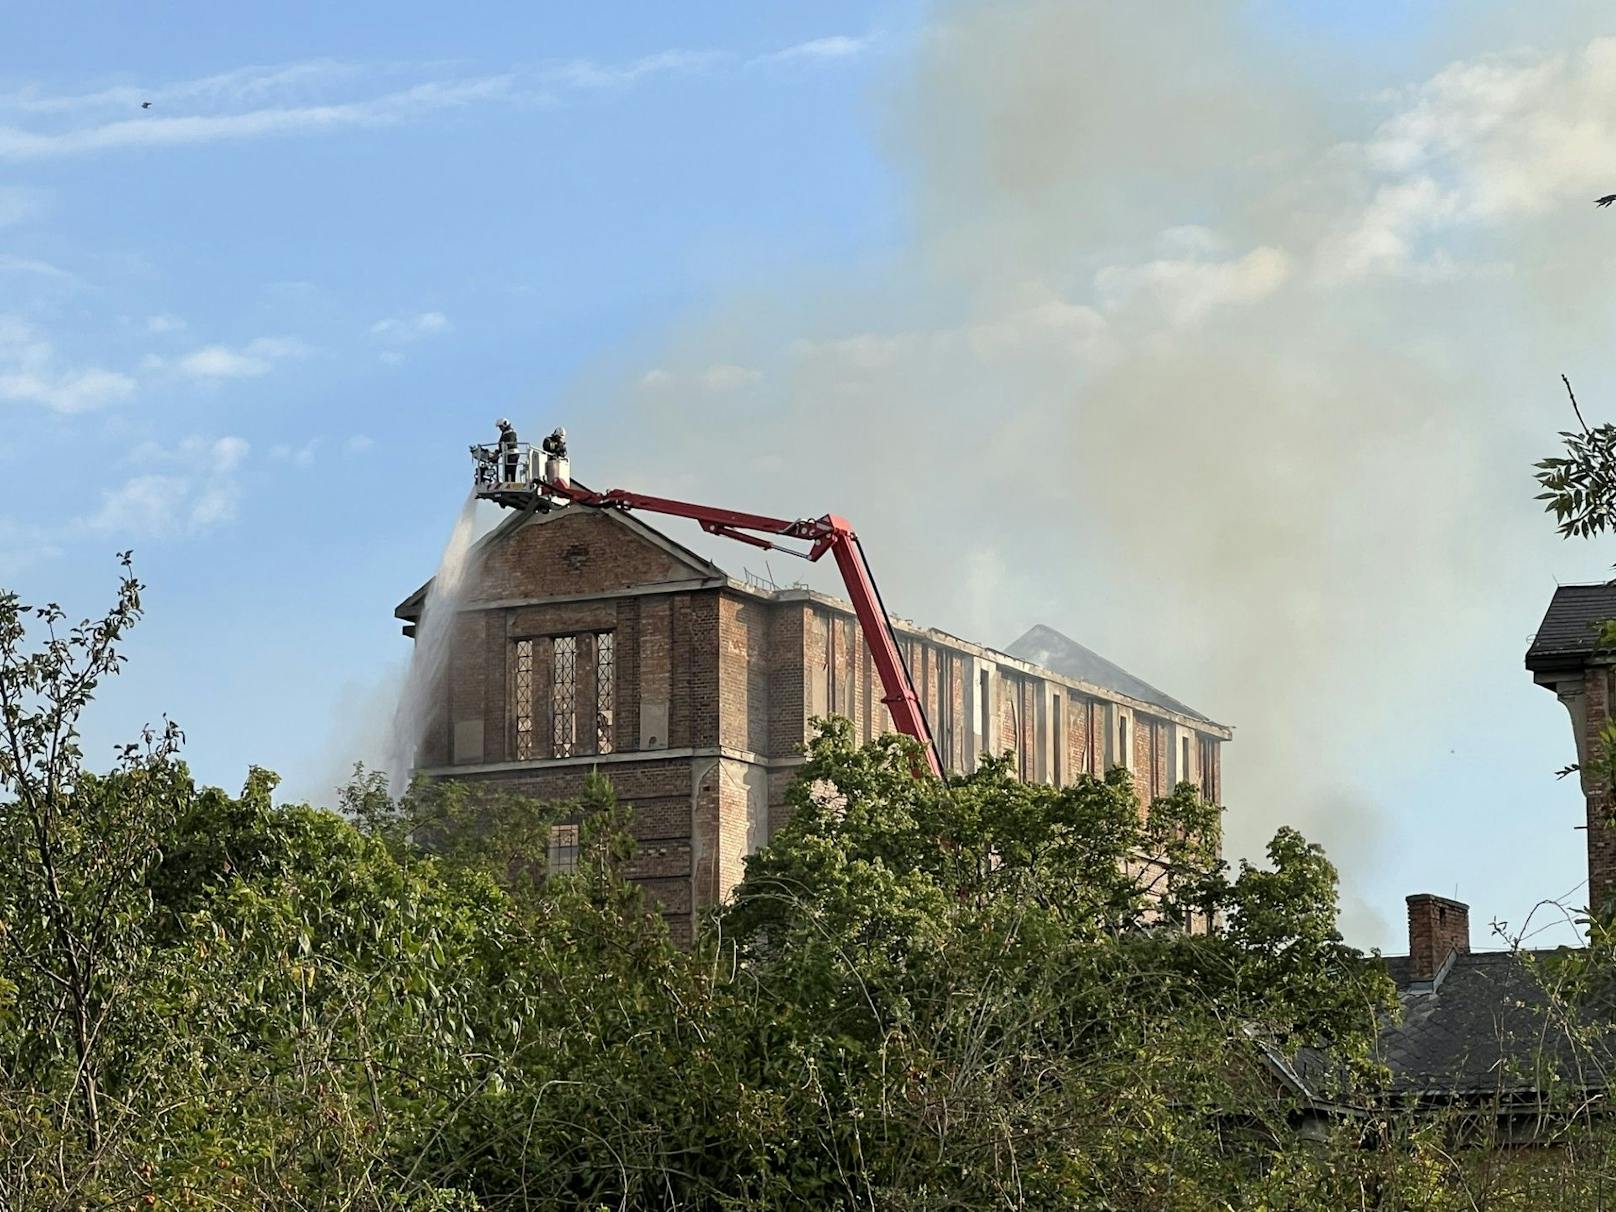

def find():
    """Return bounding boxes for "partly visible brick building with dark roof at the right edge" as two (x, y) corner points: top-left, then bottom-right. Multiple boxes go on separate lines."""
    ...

(1526, 582), (1616, 910)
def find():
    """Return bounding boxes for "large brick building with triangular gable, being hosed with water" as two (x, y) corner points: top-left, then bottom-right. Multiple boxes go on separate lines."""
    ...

(396, 506), (1231, 937)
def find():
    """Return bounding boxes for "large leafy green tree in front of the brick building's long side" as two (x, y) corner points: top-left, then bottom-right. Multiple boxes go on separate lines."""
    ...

(719, 721), (1390, 1207)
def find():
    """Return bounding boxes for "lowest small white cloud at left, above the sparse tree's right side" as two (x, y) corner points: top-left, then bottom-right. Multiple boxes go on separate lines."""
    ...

(82, 436), (249, 538)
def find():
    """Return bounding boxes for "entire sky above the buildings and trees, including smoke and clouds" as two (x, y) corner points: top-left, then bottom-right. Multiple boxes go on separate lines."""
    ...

(9, 0), (1616, 950)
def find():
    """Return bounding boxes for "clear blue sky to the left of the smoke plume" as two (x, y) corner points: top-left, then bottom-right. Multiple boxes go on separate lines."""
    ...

(0, 3), (911, 798)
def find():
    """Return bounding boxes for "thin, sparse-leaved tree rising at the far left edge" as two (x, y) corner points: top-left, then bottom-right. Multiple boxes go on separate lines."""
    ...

(0, 554), (167, 1159)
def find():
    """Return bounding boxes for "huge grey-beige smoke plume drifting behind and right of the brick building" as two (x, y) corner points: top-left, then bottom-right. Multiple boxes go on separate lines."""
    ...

(574, 0), (1616, 949)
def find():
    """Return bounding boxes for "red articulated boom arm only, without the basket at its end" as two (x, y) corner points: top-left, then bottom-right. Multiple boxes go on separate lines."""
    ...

(543, 483), (942, 779)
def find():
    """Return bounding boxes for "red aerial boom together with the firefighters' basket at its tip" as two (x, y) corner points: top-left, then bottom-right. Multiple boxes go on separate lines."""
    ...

(472, 430), (942, 779)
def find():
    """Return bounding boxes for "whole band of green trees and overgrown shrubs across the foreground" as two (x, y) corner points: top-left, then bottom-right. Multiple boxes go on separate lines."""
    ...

(0, 574), (1608, 1212)
